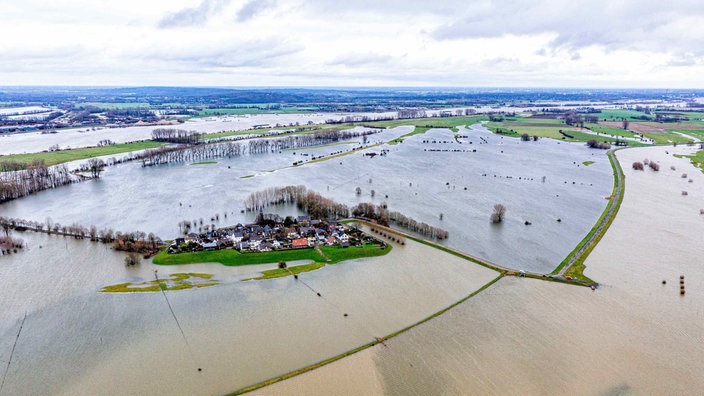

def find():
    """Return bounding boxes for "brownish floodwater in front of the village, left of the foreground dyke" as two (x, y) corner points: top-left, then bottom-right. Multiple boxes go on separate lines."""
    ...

(0, 233), (497, 395)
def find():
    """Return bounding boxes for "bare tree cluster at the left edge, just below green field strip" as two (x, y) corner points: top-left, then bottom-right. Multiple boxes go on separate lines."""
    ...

(0, 161), (77, 203)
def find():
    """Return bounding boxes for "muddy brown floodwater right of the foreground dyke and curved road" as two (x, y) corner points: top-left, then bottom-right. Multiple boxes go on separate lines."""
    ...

(259, 147), (704, 395)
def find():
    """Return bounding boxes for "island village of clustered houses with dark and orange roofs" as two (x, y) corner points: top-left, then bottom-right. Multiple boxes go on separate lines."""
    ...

(167, 214), (385, 254)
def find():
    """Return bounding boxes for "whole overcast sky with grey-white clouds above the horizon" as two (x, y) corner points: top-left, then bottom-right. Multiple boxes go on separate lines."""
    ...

(0, 0), (704, 88)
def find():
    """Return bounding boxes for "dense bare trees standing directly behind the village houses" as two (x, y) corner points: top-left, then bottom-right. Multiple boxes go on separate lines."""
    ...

(244, 186), (349, 219)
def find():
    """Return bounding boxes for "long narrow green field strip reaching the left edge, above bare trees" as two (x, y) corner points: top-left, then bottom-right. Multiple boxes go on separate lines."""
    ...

(0, 140), (166, 165)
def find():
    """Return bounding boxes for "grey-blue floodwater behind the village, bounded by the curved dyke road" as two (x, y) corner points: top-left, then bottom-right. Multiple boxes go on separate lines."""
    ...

(0, 126), (613, 273)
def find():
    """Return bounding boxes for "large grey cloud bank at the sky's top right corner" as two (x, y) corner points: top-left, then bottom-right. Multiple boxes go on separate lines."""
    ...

(429, 0), (704, 56)
